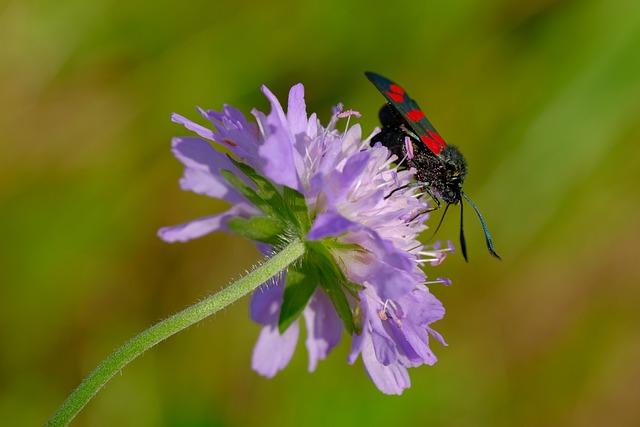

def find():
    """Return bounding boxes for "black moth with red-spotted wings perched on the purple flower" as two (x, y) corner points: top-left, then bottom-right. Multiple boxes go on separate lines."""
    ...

(365, 72), (500, 261)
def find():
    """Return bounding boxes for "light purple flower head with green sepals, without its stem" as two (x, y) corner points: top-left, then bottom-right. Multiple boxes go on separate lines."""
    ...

(159, 84), (453, 394)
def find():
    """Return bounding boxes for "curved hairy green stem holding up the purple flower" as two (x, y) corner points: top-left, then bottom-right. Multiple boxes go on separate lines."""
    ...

(47, 240), (304, 426)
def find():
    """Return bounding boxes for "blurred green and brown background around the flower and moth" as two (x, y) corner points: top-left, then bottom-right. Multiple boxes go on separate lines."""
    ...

(0, 0), (640, 427)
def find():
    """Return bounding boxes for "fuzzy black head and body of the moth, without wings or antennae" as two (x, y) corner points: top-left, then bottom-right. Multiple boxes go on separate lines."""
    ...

(373, 104), (467, 204)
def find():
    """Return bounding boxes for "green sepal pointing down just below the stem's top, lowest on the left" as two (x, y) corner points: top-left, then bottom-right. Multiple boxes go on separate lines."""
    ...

(278, 267), (318, 334)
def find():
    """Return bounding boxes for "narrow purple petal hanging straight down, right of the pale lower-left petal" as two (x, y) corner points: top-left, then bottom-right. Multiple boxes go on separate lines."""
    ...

(303, 289), (342, 372)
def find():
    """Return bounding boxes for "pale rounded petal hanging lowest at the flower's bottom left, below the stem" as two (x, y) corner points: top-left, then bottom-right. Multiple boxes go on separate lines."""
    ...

(251, 322), (299, 378)
